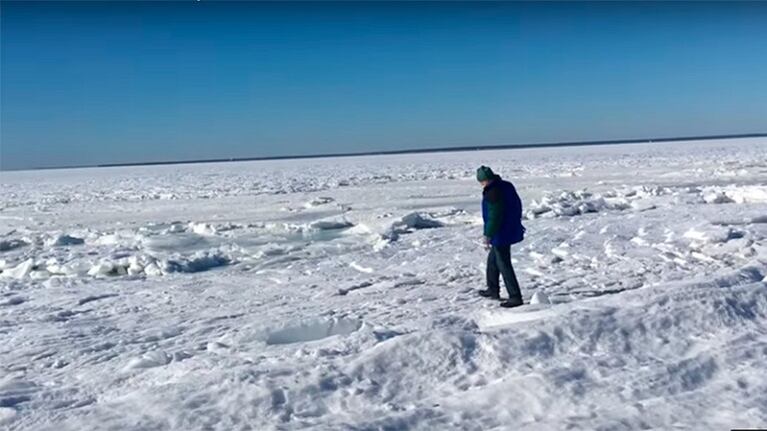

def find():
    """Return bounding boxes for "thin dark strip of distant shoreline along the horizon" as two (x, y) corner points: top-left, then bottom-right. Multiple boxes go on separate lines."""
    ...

(3, 133), (767, 172)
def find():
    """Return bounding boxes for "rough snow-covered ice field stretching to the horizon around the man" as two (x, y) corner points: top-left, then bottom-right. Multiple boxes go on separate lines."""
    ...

(0, 139), (767, 430)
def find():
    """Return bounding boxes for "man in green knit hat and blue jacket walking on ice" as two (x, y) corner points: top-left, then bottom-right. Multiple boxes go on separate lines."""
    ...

(477, 166), (525, 308)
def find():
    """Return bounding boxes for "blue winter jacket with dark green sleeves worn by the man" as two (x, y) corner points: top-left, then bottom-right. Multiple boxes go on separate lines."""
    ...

(482, 175), (525, 246)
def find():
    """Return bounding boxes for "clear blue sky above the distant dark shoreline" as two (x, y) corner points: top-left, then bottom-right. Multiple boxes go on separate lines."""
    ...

(0, 1), (767, 169)
